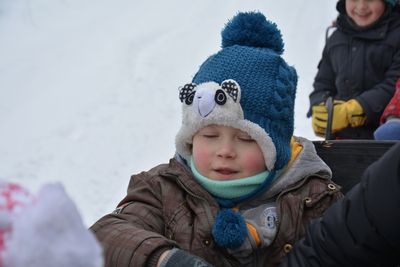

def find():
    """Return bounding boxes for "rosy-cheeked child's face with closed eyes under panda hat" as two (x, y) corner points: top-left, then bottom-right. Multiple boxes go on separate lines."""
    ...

(192, 125), (266, 180)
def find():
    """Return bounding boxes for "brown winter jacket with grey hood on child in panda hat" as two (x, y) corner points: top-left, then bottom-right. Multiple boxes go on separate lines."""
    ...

(91, 138), (342, 267)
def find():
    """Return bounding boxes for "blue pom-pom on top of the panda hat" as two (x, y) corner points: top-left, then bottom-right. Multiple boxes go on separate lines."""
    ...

(221, 12), (284, 54)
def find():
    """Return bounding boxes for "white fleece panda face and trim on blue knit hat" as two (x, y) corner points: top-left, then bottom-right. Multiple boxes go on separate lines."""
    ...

(175, 79), (276, 170)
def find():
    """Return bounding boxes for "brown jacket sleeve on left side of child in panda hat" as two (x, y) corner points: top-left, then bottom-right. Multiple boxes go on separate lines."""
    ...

(90, 173), (177, 267)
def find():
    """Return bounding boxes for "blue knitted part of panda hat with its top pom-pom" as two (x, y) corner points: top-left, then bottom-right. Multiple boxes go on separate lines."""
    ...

(188, 12), (297, 169)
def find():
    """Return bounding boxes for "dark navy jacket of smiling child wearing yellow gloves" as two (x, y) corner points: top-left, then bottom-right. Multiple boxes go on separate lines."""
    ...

(308, 1), (400, 139)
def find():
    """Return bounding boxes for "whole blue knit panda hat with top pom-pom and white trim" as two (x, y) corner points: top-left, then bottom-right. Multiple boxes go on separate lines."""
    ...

(176, 12), (297, 170)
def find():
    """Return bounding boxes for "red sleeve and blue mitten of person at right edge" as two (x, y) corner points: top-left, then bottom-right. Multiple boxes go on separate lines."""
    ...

(374, 79), (400, 140)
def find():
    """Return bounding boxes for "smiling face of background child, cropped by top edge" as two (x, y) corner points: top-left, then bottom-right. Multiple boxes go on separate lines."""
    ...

(346, 0), (385, 27)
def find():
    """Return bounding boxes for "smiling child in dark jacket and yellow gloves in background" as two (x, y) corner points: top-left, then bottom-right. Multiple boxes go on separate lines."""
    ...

(308, 0), (400, 139)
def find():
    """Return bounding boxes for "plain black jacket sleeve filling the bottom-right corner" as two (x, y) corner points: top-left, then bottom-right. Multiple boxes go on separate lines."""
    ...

(281, 143), (400, 267)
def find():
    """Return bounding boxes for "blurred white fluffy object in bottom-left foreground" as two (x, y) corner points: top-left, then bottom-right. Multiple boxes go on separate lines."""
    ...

(0, 184), (103, 267)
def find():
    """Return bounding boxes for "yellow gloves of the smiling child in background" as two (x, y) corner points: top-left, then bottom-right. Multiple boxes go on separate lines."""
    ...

(312, 99), (366, 136)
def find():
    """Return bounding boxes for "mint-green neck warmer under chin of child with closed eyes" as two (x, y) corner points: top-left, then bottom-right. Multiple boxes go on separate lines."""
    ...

(190, 158), (269, 199)
